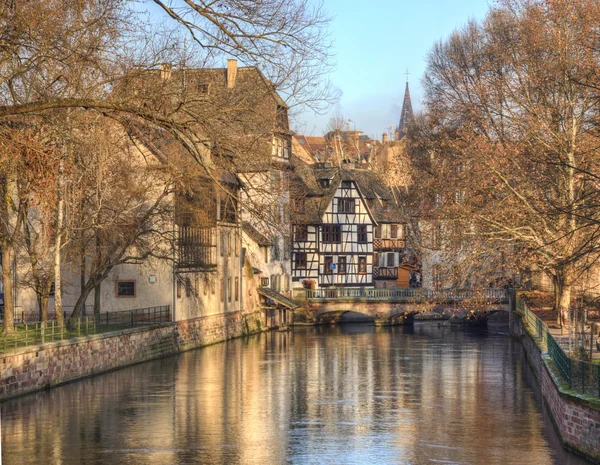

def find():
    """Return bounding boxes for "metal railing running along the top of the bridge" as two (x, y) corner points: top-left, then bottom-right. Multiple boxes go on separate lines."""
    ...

(306, 287), (508, 302)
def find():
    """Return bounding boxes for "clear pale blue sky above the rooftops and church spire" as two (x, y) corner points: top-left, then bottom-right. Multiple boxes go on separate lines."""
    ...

(293, 0), (493, 139)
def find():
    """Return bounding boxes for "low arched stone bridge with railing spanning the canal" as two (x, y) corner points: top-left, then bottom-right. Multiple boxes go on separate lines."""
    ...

(306, 288), (509, 325)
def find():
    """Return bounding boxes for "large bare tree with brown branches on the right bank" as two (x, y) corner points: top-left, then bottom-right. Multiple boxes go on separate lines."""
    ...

(412, 0), (600, 330)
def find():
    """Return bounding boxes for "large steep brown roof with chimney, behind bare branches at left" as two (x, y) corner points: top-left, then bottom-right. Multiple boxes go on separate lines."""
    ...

(120, 66), (291, 173)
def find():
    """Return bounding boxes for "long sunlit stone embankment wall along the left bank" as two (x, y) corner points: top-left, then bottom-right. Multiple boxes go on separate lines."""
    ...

(0, 312), (261, 400)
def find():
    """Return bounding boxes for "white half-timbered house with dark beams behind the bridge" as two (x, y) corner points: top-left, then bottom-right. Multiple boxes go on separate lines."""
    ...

(292, 159), (409, 288)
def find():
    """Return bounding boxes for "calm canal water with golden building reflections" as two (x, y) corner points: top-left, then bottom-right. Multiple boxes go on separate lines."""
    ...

(2, 324), (587, 465)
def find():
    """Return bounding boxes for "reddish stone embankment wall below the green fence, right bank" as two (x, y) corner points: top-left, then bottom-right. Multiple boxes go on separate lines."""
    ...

(510, 313), (600, 463)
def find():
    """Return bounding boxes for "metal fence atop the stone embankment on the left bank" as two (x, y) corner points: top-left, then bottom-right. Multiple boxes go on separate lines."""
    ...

(0, 305), (171, 352)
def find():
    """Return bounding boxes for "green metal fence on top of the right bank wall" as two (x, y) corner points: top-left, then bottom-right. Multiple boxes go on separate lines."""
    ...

(516, 300), (600, 397)
